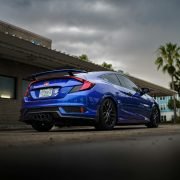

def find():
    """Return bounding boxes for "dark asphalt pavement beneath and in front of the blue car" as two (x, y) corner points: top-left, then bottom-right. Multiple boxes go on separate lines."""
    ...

(0, 125), (180, 180)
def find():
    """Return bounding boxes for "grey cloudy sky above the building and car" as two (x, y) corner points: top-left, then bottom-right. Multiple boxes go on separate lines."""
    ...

(0, 0), (180, 87)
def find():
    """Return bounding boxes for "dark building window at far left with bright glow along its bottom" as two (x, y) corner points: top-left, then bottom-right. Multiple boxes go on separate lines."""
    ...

(0, 76), (16, 99)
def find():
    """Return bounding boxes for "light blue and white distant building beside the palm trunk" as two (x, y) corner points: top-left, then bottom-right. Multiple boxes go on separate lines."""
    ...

(155, 94), (180, 122)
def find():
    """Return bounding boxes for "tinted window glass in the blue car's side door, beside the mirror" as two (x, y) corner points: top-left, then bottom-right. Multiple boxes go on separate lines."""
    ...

(117, 74), (139, 91)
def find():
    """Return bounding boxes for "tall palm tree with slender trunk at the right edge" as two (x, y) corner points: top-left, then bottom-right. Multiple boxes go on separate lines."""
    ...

(155, 43), (180, 123)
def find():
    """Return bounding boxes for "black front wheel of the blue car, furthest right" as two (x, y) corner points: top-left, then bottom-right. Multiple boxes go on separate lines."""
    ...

(146, 107), (160, 128)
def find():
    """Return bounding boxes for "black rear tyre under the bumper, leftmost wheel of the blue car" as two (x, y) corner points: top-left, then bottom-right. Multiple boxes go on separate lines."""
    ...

(31, 114), (54, 132)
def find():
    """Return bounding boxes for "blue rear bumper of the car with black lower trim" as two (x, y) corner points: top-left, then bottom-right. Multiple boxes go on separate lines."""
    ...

(20, 90), (101, 123)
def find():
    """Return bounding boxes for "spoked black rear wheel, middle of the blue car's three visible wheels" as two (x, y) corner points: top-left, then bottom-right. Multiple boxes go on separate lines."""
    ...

(95, 98), (117, 130)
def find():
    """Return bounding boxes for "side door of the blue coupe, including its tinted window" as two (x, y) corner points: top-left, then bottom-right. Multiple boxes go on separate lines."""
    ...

(116, 74), (151, 123)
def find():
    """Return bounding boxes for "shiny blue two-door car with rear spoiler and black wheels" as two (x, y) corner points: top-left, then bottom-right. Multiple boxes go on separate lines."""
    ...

(21, 69), (160, 131)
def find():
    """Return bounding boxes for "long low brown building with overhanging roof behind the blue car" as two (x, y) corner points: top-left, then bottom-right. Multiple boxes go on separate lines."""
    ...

(0, 22), (175, 125)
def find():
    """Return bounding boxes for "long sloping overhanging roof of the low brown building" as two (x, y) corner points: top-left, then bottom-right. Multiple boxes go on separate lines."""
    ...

(0, 33), (176, 96)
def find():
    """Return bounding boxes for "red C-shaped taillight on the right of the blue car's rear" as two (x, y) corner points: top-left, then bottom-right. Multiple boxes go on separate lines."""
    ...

(70, 77), (95, 93)
